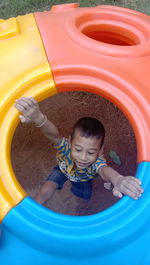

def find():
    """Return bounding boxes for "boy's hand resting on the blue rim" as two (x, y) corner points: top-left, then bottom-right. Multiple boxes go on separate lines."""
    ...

(112, 175), (144, 200)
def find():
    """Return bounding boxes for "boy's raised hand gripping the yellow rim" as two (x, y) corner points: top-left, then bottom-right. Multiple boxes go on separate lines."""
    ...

(15, 97), (44, 125)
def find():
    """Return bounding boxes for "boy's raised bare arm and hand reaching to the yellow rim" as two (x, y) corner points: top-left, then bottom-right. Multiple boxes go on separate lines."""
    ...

(15, 97), (60, 144)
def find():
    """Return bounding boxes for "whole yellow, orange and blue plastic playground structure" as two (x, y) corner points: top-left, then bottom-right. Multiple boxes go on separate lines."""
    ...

(0, 3), (150, 265)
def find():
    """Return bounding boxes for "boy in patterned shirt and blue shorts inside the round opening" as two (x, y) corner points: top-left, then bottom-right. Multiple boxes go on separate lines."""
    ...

(15, 97), (143, 204)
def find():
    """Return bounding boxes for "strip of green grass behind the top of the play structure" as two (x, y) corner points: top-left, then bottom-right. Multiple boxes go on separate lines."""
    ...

(0, 0), (150, 18)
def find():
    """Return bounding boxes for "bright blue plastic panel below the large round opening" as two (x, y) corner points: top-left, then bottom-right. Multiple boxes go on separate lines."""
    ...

(0, 162), (150, 265)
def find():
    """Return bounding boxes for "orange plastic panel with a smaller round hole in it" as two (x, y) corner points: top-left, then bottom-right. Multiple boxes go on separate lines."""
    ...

(35, 6), (150, 162)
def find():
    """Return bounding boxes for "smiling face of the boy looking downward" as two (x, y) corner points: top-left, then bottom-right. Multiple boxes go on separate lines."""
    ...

(71, 129), (101, 169)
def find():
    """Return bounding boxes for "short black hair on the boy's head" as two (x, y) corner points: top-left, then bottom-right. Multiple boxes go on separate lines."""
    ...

(71, 117), (105, 146)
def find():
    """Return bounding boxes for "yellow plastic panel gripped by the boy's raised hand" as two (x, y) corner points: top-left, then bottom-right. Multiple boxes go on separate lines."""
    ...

(0, 14), (57, 220)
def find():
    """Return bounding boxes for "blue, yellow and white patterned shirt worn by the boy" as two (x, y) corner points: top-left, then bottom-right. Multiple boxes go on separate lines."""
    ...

(54, 137), (107, 182)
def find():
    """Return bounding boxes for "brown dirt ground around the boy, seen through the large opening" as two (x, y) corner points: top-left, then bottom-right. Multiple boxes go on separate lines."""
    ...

(12, 91), (137, 215)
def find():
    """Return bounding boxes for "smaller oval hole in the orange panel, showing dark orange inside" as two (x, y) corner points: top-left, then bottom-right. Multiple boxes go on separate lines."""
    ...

(82, 25), (140, 46)
